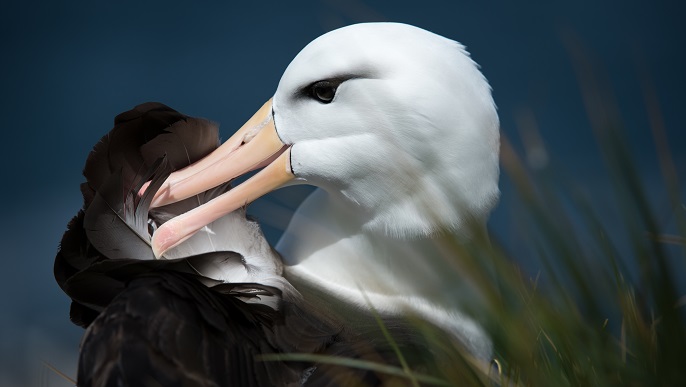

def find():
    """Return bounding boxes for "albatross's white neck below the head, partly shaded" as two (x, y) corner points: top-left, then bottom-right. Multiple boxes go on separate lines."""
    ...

(276, 189), (491, 358)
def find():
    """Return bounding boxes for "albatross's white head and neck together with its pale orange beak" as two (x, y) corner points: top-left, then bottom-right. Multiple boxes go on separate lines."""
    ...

(152, 23), (499, 358)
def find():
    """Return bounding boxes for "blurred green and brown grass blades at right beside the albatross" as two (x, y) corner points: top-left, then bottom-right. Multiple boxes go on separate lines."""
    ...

(396, 62), (686, 386)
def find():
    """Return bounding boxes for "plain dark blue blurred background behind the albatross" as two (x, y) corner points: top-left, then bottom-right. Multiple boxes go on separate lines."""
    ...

(0, 0), (686, 386)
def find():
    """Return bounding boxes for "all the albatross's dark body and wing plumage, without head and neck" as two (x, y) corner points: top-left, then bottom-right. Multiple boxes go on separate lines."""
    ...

(55, 103), (452, 386)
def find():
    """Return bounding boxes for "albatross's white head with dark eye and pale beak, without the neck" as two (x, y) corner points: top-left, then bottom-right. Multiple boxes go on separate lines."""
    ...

(153, 23), (499, 255)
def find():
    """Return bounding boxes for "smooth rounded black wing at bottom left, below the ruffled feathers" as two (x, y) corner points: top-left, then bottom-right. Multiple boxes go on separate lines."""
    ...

(78, 271), (307, 386)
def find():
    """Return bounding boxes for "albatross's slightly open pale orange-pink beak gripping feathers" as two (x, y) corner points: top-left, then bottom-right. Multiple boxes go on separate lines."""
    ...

(144, 99), (295, 257)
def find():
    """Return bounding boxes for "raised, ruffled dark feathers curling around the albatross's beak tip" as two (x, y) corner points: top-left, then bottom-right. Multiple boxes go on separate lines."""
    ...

(54, 102), (231, 326)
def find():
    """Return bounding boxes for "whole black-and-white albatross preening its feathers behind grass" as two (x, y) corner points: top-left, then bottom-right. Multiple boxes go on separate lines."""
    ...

(55, 23), (499, 385)
